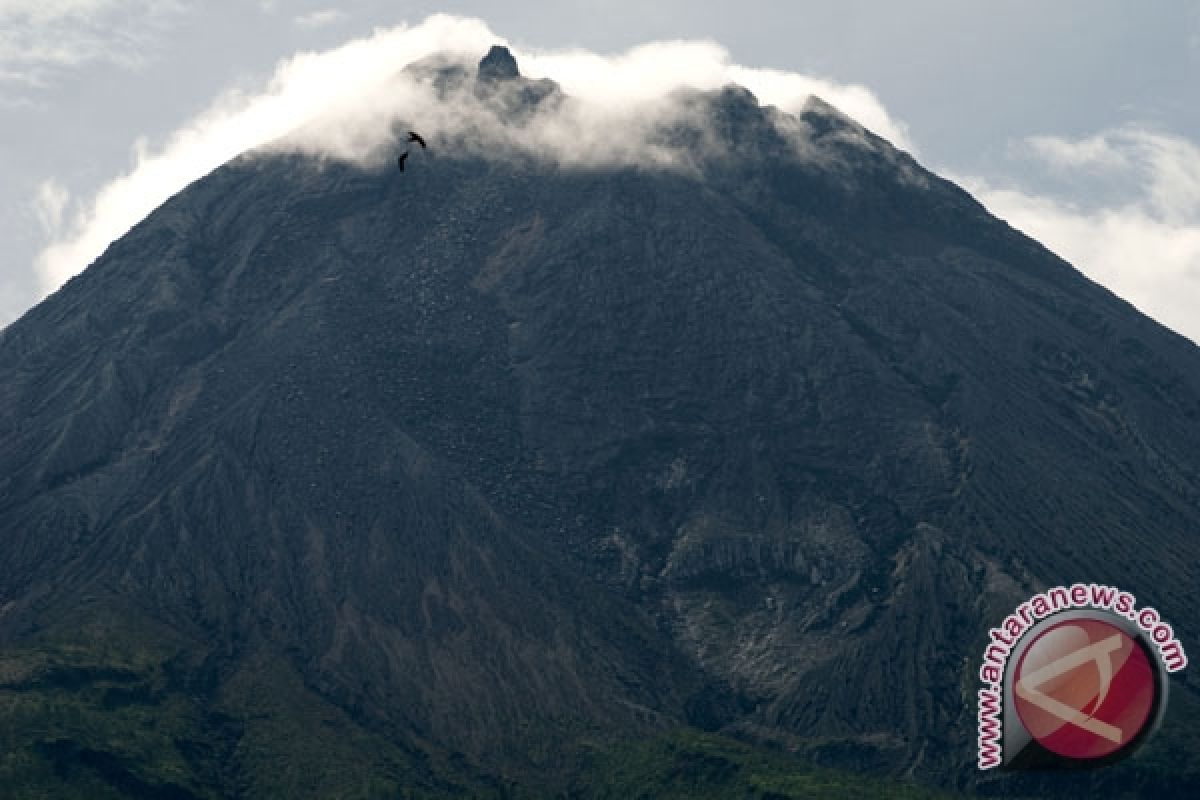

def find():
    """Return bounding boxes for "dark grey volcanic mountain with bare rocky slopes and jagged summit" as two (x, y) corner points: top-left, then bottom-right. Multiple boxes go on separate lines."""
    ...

(0, 50), (1200, 798)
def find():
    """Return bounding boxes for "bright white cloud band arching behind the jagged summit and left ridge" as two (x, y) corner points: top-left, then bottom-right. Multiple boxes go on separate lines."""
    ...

(28, 14), (912, 303)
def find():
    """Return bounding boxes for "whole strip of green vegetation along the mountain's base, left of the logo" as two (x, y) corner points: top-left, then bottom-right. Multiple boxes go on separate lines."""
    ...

(0, 614), (955, 800)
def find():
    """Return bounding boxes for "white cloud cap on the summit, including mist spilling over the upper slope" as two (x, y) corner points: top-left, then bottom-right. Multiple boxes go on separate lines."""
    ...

(37, 14), (912, 297)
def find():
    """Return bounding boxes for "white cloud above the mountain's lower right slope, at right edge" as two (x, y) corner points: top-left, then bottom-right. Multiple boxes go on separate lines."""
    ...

(961, 128), (1200, 342)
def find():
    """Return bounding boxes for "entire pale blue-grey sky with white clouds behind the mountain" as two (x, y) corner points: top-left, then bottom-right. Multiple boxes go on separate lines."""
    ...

(0, 0), (1200, 341)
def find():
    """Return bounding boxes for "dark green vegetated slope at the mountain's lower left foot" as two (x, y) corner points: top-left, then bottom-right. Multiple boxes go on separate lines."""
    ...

(0, 609), (497, 800)
